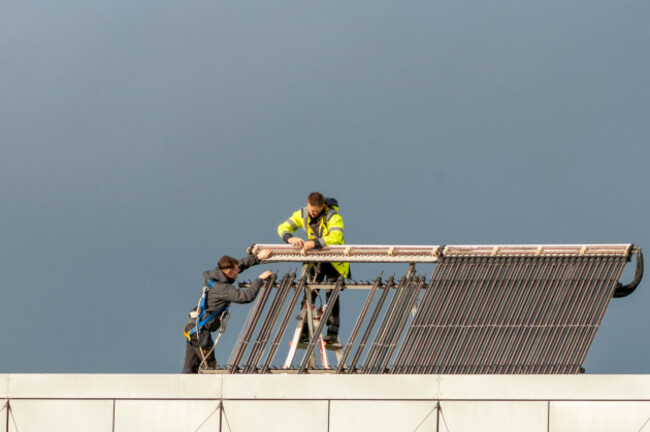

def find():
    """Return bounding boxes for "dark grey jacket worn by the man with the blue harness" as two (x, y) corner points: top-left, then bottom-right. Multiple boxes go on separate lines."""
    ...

(203, 255), (264, 331)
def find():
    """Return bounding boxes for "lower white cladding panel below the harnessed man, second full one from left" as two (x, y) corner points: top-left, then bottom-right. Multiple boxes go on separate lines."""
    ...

(115, 400), (219, 432)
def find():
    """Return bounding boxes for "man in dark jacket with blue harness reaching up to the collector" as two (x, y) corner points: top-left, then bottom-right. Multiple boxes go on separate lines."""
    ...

(183, 250), (272, 373)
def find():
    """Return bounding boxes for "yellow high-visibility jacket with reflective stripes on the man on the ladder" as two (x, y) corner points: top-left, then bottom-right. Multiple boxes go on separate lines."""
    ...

(278, 204), (350, 277)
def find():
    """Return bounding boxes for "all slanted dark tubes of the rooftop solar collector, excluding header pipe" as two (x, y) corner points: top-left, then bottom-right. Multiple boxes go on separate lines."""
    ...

(221, 246), (629, 374)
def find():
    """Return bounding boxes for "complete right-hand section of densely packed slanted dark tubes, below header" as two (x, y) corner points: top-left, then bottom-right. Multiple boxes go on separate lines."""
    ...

(391, 257), (626, 374)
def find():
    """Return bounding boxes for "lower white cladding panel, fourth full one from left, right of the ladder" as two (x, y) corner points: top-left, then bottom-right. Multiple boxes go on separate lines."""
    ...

(329, 400), (436, 432)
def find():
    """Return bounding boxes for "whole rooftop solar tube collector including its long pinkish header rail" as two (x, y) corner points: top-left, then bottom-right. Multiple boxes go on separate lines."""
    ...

(220, 244), (642, 374)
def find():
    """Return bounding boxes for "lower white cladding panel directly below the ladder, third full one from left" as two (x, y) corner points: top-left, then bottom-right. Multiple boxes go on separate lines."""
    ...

(223, 400), (332, 432)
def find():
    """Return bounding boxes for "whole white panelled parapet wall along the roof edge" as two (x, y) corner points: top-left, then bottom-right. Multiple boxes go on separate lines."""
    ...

(0, 374), (650, 432)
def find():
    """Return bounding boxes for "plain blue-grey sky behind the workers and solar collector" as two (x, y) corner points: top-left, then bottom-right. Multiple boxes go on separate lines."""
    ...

(0, 0), (650, 373)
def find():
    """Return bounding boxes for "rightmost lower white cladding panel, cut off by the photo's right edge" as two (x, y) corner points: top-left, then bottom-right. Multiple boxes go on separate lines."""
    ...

(549, 401), (650, 432)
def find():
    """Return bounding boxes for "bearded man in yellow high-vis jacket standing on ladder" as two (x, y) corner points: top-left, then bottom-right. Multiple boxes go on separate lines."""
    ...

(278, 192), (350, 343)
